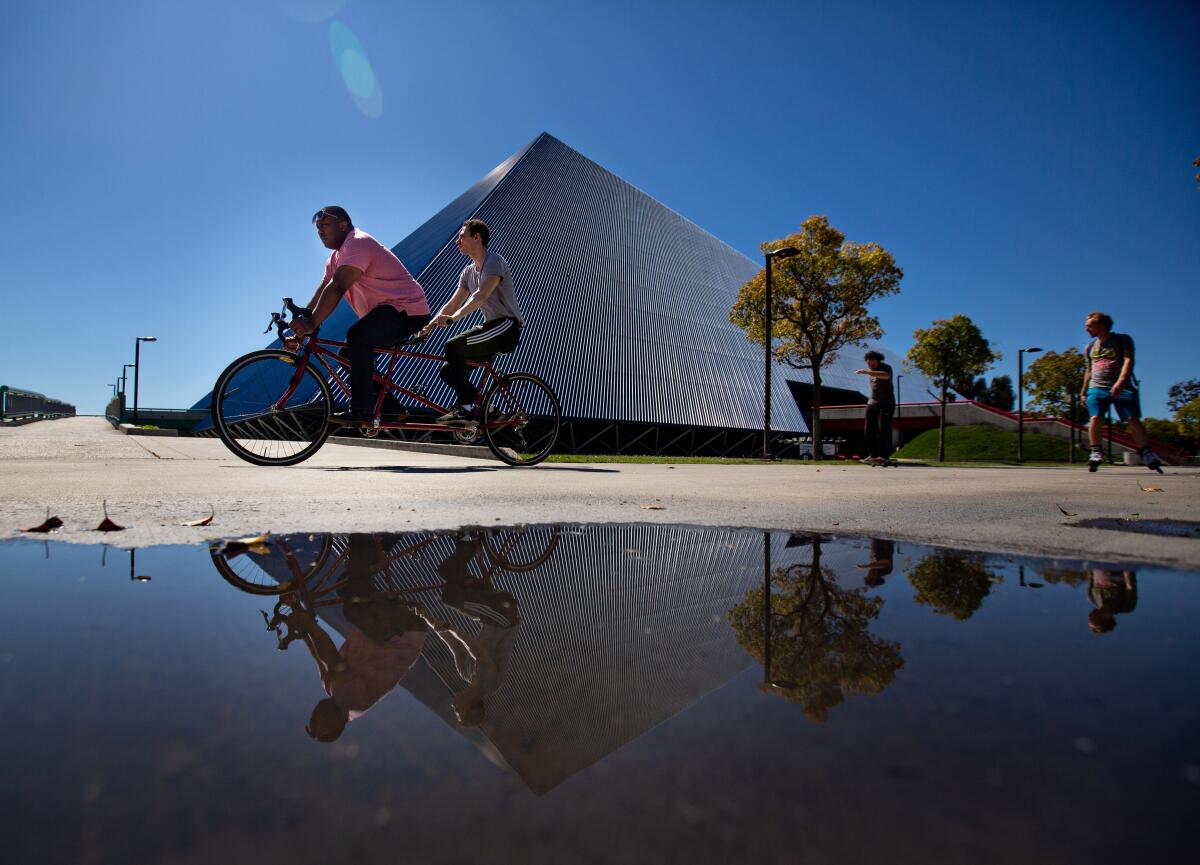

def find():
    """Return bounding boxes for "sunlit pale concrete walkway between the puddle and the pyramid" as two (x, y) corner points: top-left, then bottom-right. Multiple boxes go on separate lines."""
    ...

(0, 418), (1200, 569)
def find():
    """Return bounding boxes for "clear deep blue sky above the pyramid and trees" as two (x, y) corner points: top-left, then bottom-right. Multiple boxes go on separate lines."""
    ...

(0, 0), (1200, 415)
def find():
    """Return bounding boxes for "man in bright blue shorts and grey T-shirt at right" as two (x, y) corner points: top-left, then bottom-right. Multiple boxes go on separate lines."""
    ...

(1081, 312), (1163, 473)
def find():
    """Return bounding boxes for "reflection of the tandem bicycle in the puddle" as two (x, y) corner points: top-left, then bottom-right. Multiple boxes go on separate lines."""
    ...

(210, 527), (559, 597)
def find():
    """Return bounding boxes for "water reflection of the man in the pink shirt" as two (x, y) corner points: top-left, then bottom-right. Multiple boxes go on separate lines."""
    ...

(295, 534), (470, 741)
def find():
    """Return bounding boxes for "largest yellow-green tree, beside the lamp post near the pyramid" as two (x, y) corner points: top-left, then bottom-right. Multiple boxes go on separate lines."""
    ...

(730, 216), (904, 459)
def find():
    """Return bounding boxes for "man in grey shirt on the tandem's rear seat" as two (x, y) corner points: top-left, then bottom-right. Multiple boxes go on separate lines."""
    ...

(425, 220), (524, 426)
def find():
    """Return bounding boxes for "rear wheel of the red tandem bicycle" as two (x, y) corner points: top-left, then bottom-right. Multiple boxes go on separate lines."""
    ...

(481, 372), (563, 465)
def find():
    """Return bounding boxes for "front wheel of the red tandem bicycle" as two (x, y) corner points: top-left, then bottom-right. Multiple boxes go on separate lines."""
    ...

(212, 349), (334, 465)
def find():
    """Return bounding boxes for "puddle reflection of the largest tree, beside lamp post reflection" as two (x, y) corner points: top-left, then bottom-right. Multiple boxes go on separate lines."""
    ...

(730, 540), (904, 721)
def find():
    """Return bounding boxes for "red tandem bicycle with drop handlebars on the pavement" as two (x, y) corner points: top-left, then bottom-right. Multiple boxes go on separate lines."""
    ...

(212, 298), (562, 465)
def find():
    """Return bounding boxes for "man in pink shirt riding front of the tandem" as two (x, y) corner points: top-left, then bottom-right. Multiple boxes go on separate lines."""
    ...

(292, 205), (430, 424)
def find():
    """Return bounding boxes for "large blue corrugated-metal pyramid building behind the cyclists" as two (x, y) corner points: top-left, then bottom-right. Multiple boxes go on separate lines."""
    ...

(197, 133), (919, 455)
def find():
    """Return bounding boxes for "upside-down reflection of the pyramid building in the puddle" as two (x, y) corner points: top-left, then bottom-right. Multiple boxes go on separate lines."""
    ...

(270, 525), (803, 793)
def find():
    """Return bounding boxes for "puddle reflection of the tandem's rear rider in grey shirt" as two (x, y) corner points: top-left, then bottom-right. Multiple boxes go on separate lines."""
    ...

(438, 533), (521, 727)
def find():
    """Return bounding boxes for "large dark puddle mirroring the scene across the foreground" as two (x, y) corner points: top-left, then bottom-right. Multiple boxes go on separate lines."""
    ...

(0, 524), (1200, 865)
